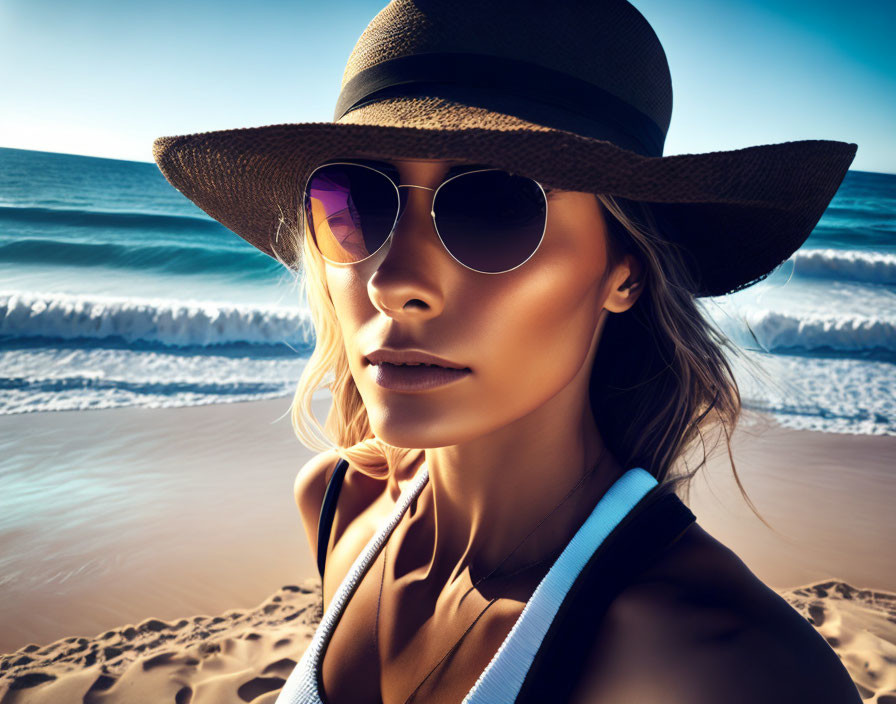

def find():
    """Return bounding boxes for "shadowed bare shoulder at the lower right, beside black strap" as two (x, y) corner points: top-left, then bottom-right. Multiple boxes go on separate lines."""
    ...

(571, 523), (861, 704)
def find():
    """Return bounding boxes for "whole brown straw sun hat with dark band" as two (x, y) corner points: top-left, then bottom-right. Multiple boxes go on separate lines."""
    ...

(153, 0), (857, 296)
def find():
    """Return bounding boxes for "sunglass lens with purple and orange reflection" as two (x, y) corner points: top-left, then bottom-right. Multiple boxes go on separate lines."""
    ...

(304, 164), (398, 264)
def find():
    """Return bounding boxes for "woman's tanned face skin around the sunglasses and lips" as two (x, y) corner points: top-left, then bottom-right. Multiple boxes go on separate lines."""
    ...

(325, 160), (633, 449)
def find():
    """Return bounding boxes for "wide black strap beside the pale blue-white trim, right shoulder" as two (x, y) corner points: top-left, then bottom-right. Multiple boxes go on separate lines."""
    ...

(515, 486), (696, 704)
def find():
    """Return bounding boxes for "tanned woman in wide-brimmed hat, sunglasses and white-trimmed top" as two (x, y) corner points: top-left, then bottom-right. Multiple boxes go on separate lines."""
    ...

(155, 0), (860, 704)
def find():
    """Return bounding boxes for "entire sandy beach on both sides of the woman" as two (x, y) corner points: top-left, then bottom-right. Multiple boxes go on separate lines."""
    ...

(0, 398), (896, 704)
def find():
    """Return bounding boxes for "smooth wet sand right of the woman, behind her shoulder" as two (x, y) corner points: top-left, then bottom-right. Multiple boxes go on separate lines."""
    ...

(685, 411), (896, 591)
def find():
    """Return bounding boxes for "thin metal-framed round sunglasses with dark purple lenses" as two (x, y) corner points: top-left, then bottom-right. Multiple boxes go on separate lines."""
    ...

(303, 160), (552, 274)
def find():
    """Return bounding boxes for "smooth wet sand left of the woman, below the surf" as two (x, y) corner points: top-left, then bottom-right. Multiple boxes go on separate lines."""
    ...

(0, 398), (329, 652)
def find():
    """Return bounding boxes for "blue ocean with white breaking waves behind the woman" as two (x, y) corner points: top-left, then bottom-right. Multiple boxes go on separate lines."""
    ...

(0, 148), (896, 435)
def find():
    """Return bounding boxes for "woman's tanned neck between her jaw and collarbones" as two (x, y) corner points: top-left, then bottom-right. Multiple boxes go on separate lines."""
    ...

(410, 376), (623, 585)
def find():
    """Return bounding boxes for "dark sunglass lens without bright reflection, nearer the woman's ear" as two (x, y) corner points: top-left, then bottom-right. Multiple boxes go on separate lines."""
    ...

(434, 170), (547, 274)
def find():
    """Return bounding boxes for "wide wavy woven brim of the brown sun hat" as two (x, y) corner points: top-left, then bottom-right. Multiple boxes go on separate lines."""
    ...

(153, 98), (857, 296)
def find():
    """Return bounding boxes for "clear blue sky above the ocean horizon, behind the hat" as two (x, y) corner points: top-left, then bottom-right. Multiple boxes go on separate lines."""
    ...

(0, 0), (896, 173)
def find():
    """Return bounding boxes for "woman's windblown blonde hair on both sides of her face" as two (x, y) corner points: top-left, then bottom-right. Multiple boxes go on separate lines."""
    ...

(289, 187), (774, 530)
